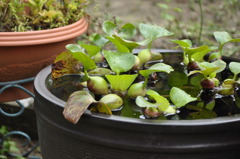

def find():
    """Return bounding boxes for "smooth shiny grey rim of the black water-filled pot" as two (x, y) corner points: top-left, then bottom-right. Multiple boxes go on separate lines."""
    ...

(34, 49), (240, 127)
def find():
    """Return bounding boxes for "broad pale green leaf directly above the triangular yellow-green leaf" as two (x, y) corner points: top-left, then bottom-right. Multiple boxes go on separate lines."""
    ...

(103, 50), (135, 74)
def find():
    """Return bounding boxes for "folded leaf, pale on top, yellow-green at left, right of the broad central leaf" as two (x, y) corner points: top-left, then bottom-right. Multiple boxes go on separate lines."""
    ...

(139, 63), (174, 78)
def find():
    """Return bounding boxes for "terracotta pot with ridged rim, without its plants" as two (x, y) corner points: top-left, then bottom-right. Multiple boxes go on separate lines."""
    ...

(0, 18), (88, 102)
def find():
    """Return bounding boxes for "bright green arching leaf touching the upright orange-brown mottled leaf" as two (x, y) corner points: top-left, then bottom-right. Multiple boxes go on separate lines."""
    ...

(72, 52), (97, 70)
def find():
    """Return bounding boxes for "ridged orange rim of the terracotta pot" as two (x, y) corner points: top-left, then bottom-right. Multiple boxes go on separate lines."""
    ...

(0, 18), (89, 46)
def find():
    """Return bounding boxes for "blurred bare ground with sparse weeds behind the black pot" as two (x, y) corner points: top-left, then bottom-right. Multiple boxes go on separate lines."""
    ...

(88, 0), (240, 57)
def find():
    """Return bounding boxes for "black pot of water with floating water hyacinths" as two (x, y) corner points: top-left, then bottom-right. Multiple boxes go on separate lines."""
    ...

(35, 21), (240, 159)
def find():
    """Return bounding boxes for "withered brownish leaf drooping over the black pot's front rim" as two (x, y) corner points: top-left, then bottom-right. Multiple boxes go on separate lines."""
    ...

(63, 91), (95, 124)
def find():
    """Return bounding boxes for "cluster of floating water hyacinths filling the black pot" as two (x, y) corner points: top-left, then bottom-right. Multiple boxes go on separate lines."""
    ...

(50, 21), (240, 123)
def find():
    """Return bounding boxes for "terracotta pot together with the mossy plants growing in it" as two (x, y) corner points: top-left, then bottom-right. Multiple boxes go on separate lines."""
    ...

(0, 0), (89, 102)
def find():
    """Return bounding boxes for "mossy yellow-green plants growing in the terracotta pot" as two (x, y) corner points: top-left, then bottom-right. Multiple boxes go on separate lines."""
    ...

(0, 0), (90, 32)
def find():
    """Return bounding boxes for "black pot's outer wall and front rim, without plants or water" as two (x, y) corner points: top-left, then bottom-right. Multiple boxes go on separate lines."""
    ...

(34, 50), (240, 159)
